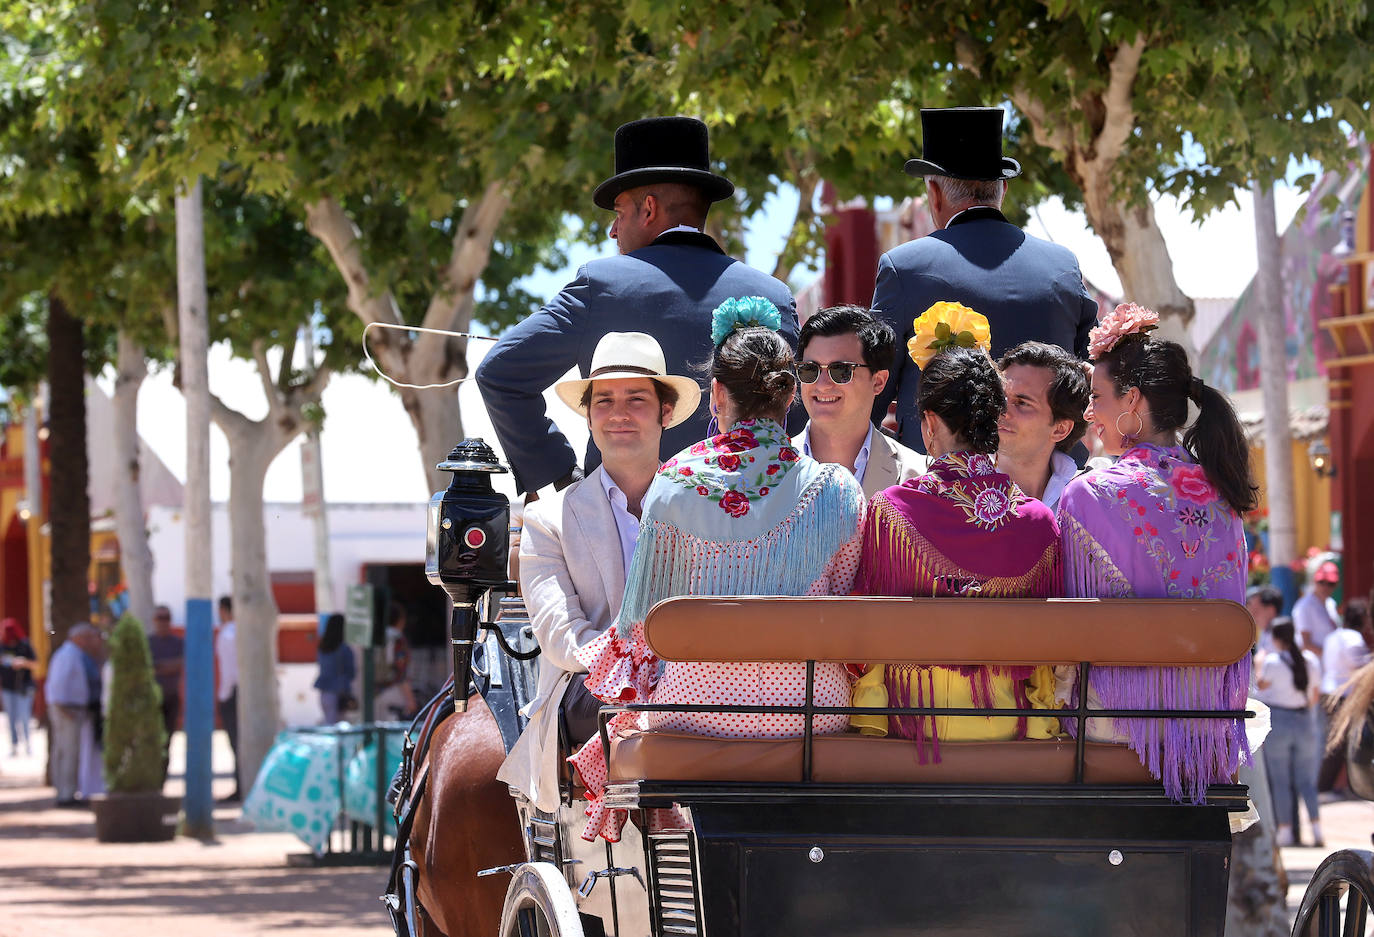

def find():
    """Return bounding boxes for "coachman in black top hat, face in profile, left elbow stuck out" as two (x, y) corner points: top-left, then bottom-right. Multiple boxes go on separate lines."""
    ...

(477, 117), (797, 492)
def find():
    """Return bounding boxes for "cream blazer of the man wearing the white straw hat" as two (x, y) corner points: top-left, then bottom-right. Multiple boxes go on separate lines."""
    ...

(496, 467), (625, 811)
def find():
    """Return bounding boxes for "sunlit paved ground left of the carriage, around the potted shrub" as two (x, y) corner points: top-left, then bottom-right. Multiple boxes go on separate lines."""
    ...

(0, 732), (392, 937)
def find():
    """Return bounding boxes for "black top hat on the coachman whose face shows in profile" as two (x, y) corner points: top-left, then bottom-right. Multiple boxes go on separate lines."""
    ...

(592, 117), (735, 210)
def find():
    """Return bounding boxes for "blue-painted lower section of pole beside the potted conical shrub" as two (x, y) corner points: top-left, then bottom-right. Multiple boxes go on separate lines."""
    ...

(181, 599), (214, 839)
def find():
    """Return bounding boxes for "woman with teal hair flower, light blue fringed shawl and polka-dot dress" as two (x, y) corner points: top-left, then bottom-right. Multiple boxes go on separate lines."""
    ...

(570, 297), (864, 842)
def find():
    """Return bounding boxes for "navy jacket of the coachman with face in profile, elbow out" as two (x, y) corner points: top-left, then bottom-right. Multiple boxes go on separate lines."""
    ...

(477, 232), (797, 492)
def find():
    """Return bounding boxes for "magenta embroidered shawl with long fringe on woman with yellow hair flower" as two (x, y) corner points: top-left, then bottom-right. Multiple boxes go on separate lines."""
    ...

(855, 452), (1059, 763)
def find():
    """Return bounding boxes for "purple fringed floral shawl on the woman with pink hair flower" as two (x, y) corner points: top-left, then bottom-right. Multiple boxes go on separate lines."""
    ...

(1059, 444), (1250, 802)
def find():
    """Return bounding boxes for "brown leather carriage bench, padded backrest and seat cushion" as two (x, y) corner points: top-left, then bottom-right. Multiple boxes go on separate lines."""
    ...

(610, 596), (1254, 784)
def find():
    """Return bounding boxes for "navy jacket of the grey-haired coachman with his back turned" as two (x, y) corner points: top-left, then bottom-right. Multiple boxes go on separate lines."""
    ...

(872, 207), (1098, 452)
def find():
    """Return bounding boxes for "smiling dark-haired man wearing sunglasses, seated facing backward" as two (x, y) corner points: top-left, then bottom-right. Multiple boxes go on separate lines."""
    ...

(794, 306), (926, 497)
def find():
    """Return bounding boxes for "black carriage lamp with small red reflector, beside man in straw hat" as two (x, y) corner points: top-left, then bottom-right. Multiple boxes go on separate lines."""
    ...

(425, 438), (514, 712)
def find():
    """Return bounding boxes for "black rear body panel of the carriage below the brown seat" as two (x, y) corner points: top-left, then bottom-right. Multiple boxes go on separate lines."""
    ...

(667, 790), (1231, 937)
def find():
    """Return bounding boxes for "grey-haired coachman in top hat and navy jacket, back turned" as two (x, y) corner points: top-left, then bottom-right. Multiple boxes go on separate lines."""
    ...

(872, 107), (1098, 452)
